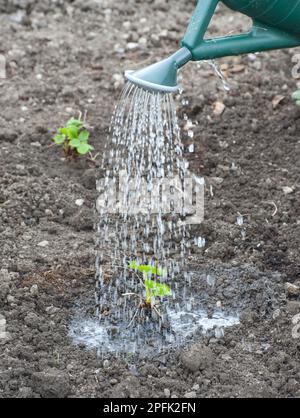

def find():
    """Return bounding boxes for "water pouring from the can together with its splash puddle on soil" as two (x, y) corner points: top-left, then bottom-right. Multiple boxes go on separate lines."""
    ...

(71, 83), (239, 355)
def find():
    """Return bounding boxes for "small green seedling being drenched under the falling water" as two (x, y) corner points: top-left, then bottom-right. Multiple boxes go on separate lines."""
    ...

(123, 261), (172, 326)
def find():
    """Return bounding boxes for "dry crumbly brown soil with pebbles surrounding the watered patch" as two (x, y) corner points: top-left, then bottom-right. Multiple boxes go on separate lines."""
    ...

(0, 0), (300, 397)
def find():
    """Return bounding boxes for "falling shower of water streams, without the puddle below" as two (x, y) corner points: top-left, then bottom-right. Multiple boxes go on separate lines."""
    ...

(96, 84), (189, 350)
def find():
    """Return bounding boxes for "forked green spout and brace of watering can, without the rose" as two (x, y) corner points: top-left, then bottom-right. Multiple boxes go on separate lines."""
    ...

(182, 0), (300, 61)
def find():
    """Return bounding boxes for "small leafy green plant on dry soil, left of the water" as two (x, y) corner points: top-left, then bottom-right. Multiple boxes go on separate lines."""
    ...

(53, 118), (94, 159)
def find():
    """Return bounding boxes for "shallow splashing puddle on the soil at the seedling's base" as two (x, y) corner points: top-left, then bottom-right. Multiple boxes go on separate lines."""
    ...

(69, 309), (240, 357)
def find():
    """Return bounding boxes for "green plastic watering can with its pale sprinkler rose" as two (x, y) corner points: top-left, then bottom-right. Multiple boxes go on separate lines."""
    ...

(125, 0), (300, 92)
